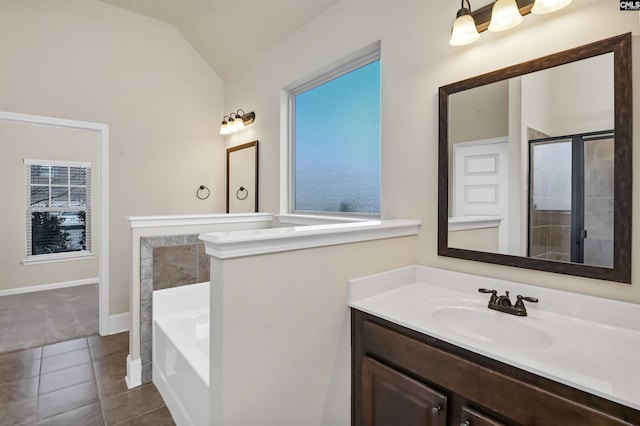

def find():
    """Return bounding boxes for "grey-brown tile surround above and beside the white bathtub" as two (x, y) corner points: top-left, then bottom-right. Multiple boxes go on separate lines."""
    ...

(140, 234), (209, 383)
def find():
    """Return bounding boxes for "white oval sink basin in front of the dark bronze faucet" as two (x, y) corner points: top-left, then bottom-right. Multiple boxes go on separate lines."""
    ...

(432, 306), (552, 349)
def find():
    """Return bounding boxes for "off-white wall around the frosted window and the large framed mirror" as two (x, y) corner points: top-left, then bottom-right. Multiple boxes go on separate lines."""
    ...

(225, 0), (640, 301)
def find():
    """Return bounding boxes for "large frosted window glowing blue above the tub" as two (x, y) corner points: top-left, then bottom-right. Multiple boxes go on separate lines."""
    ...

(289, 46), (380, 215)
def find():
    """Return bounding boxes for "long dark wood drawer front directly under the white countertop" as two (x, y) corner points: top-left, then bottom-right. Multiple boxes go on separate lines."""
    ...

(360, 320), (637, 426)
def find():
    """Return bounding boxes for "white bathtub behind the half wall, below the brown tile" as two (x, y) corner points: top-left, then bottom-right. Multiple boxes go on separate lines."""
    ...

(153, 282), (209, 426)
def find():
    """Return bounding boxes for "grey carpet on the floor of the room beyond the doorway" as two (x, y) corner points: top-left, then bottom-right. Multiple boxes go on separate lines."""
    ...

(0, 284), (98, 352)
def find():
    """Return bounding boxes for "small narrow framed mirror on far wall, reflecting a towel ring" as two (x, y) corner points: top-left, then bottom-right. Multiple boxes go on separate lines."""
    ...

(227, 141), (258, 213)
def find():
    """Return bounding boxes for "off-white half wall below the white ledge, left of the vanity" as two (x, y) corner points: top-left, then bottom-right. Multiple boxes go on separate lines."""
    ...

(209, 236), (416, 426)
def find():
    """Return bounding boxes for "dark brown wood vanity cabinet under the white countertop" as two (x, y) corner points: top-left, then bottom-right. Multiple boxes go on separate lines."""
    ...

(351, 309), (640, 426)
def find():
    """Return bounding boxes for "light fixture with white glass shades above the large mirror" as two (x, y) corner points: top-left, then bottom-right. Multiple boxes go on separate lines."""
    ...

(449, 0), (571, 46)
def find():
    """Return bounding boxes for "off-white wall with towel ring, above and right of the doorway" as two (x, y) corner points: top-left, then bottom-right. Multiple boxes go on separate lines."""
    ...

(0, 0), (225, 314)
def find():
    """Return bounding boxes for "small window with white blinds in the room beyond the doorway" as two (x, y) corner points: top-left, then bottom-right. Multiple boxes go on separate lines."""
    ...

(24, 160), (91, 263)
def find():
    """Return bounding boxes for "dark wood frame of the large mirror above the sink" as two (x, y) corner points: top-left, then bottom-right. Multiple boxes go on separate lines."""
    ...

(438, 33), (633, 283)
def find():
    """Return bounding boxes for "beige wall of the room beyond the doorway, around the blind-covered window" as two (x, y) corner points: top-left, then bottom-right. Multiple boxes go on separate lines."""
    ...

(0, 120), (100, 290)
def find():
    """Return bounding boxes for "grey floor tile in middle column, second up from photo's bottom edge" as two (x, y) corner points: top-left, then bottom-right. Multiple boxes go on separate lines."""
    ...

(38, 382), (98, 421)
